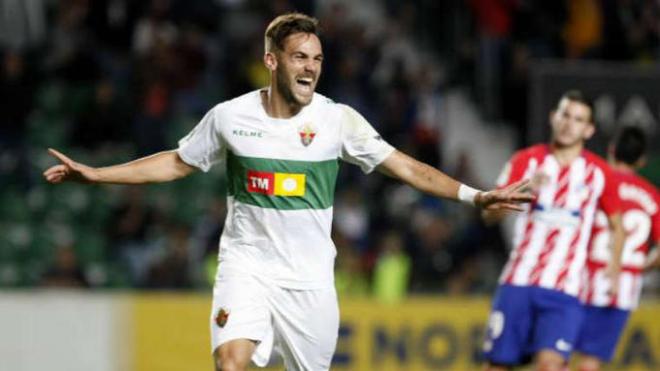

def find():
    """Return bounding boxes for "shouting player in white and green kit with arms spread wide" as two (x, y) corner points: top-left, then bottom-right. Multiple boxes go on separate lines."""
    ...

(44, 13), (532, 371)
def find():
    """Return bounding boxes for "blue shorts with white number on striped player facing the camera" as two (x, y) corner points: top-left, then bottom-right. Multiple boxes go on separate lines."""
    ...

(484, 285), (583, 366)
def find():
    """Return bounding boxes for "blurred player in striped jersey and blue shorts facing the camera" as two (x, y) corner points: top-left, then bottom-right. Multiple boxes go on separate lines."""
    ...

(483, 91), (623, 371)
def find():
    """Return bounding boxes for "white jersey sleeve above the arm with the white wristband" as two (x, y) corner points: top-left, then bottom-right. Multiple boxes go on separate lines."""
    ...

(340, 105), (394, 173)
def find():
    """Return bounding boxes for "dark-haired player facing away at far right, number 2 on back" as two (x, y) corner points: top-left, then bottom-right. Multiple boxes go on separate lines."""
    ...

(575, 127), (660, 371)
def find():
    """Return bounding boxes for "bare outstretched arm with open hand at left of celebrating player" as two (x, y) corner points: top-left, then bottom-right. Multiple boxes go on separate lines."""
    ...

(43, 148), (195, 184)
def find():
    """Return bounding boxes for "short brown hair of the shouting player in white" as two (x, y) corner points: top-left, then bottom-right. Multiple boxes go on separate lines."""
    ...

(264, 13), (319, 52)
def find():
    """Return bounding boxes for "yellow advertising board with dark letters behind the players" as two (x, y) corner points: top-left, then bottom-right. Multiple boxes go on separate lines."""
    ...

(132, 294), (660, 371)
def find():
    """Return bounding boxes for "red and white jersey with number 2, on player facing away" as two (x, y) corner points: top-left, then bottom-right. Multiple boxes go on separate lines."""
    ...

(581, 171), (660, 310)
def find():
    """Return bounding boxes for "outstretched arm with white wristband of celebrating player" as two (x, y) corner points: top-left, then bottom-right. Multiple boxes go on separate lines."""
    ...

(378, 151), (532, 211)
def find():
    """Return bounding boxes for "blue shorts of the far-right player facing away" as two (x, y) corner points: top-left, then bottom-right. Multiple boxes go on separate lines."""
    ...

(575, 305), (630, 362)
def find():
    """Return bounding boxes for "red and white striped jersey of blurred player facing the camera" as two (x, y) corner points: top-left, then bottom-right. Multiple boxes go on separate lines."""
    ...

(497, 144), (619, 296)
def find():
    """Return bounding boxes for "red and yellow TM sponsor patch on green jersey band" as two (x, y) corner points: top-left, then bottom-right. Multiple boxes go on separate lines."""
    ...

(247, 170), (305, 196)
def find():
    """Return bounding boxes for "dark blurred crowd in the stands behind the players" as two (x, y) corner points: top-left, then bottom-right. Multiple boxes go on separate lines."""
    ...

(0, 0), (660, 300)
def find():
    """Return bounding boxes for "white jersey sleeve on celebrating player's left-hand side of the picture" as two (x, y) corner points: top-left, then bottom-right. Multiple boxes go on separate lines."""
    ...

(177, 107), (226, 172)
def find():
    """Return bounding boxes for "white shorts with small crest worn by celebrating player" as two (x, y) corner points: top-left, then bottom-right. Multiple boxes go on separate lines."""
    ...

(211, 267), (339, 371)
